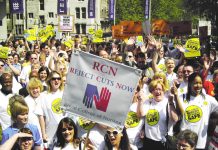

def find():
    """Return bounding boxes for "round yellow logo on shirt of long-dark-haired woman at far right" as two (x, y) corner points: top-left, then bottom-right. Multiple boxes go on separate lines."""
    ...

(185, 105), (203, 123)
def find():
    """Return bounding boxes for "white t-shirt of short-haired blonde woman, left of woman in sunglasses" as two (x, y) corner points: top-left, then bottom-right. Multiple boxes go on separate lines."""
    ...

(24, 95), (43, 136)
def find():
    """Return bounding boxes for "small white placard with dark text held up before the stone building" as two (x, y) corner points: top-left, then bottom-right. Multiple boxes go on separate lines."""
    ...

(59, 15), (74, 31)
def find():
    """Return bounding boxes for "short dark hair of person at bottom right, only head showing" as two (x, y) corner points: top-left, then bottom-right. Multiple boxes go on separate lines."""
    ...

(177, 129), (198, 147)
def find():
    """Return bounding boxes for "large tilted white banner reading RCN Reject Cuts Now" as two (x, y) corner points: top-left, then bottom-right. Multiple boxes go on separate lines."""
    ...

(62, 51), (141, 128)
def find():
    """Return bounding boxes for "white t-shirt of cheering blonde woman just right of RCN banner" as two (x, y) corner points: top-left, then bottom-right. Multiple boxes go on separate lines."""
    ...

(143, 98), (168, 141)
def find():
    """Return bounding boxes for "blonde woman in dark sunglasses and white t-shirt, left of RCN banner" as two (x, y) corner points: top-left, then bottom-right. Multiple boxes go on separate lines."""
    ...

(35, 71), (64, 144)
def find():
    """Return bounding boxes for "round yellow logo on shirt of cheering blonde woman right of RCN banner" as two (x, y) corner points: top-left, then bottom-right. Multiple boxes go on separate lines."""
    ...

(146, 109), (160, 126)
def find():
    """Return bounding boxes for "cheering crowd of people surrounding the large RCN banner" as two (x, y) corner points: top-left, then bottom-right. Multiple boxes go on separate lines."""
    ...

(0, 35), (218, 150)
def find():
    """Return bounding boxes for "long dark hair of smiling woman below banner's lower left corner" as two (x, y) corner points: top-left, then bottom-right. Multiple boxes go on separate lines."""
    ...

(55, 117), (79, 148)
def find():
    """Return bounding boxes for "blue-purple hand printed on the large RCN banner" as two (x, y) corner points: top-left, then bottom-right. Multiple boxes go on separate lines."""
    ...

(83, 84), (98, 108)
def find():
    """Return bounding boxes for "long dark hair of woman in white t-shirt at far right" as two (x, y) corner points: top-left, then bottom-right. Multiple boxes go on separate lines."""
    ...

(186, 72), (205, 101)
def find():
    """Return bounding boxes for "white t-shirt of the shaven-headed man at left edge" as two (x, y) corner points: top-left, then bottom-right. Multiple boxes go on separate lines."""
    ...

(0, 91), (13, 130)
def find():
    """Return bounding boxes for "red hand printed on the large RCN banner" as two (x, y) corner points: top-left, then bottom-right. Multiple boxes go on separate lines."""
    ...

(94, 87), (111, 112)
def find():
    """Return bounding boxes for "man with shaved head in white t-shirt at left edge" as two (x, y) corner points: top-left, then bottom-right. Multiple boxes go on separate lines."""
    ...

(0, 72), (13, 130)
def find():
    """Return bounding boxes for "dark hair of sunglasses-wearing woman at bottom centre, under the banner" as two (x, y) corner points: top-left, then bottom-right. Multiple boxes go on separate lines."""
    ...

(104, 128), (131, 150)
